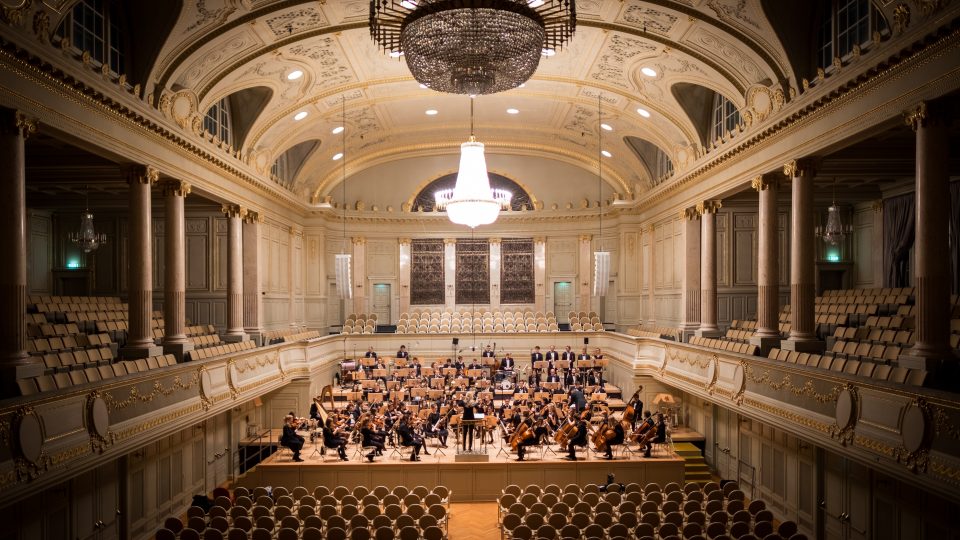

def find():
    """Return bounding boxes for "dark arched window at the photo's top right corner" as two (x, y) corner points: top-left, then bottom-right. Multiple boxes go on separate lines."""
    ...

(817, 0), (890, 70)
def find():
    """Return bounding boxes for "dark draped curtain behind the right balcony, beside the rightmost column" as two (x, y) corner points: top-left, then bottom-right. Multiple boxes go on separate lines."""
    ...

(883, 193), (917, 287)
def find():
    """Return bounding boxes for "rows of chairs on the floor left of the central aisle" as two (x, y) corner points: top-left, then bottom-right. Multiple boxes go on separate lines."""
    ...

(156, 486), (450, 540)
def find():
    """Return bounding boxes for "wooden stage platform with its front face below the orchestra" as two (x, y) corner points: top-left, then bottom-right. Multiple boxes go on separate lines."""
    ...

(236, 442), (684, 502)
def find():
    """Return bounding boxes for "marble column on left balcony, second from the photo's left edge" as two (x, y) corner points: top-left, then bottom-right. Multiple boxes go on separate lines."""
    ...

(121, 166), (163, 358)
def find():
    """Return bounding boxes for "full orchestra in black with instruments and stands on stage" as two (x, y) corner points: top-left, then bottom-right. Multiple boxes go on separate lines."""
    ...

(281, 345), (667, 462)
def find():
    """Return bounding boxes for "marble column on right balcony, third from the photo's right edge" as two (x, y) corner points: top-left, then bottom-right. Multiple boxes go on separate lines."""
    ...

(750, 175), (780, 356)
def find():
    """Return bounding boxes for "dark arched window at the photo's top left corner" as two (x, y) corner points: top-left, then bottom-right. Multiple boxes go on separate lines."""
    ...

(56, 0), (129, 74)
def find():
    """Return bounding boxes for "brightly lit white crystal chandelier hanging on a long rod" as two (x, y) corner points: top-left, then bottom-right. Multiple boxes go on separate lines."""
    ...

(434, 97), (513, 229)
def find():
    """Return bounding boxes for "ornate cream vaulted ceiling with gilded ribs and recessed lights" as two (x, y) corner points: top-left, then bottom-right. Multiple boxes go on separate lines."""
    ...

(147, 0), (793, 205)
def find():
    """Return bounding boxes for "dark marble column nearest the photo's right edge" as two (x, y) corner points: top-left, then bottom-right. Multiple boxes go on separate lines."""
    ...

(899, 103), (956, 374)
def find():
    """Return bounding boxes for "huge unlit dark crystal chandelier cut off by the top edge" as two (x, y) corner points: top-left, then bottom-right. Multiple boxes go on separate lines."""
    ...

(370, 0), (577, 95)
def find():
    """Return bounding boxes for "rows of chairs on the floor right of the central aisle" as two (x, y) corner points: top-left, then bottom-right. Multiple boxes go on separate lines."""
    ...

(497, 482), (806, 540)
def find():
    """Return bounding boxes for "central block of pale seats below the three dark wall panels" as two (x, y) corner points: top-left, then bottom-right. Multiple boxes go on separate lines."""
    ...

(397, 309), (560, 334)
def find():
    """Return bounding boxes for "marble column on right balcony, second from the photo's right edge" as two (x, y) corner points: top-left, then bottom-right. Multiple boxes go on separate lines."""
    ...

(780, 160), (824, 352)
